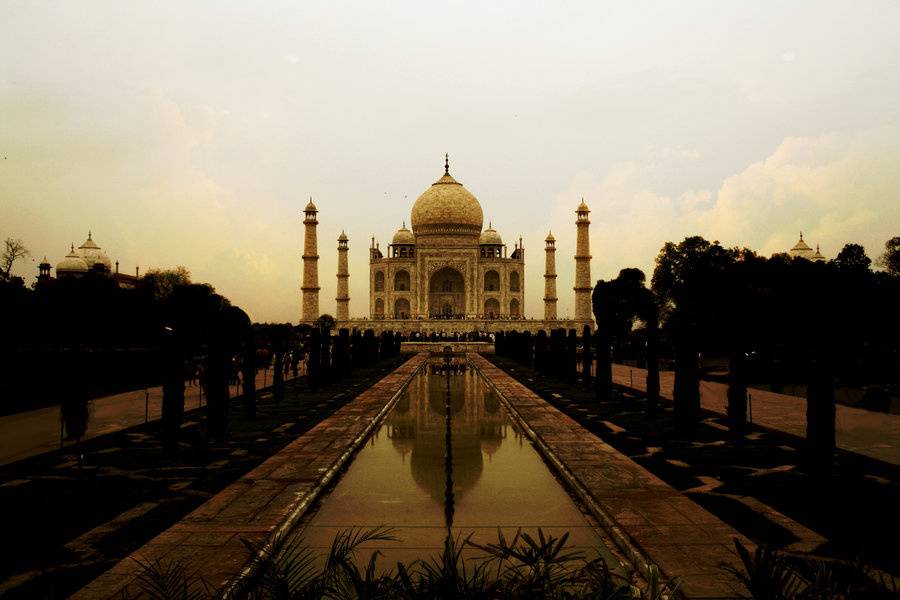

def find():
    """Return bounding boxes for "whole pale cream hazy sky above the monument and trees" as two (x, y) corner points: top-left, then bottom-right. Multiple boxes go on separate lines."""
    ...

(0, 0), (900, 322)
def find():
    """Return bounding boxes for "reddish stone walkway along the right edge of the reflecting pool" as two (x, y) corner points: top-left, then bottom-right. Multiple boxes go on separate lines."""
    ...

(470, 355), (749, 599)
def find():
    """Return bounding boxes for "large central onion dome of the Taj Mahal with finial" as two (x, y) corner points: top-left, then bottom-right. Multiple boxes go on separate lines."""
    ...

(412, 165), (484, 236)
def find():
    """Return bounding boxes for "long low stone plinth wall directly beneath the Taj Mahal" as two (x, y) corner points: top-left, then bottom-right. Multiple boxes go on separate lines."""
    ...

(336, 319), (594, 336)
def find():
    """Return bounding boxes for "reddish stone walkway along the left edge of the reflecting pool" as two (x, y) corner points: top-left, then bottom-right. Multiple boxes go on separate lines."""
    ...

(73, 353), (428, 600)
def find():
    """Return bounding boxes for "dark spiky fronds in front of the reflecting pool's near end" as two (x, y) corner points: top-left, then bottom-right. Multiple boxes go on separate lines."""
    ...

(126, 527), (677, 600)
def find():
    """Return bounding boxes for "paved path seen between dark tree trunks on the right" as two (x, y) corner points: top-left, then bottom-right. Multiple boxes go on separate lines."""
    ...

(613, 364), (900, 465)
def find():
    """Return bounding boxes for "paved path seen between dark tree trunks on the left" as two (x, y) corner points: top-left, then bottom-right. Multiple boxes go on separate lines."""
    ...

(0, 369), (300, 466)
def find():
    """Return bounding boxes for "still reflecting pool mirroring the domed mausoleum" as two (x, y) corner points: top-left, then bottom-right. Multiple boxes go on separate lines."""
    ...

(302, 365), (616, 567)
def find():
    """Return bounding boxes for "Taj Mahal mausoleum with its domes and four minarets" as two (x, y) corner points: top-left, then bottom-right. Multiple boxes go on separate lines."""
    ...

(301, 156), (593, 334)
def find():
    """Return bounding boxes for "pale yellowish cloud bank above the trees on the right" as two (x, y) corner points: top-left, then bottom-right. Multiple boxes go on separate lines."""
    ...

(544, 131), (900, 310)
